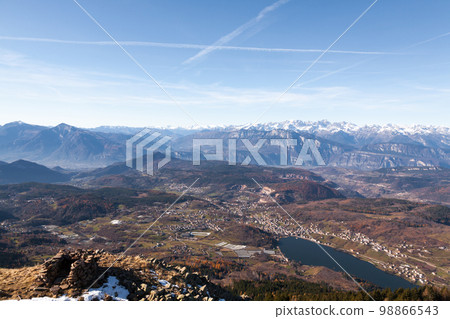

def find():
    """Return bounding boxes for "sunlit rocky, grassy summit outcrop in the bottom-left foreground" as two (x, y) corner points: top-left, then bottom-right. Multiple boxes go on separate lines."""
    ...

(0, 250), (238, 301)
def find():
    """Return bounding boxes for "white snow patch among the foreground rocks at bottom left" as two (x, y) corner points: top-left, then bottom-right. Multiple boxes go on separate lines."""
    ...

(31, 276), (129, 301)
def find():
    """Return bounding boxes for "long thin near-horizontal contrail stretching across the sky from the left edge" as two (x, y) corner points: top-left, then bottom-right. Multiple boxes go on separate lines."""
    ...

(0, 36), (395, 55)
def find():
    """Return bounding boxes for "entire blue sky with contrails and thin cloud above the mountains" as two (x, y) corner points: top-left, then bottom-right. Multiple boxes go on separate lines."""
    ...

(0, 0), (450, 127)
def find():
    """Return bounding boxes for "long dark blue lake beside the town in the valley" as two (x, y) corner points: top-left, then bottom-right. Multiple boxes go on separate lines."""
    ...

(279, 237), (417, 289)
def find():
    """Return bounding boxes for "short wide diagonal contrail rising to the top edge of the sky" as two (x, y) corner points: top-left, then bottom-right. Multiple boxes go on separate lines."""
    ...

(183, 0), (289, 64)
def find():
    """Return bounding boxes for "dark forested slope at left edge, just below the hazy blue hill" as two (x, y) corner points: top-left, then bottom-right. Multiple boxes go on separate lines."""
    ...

(0, 183), (189, 226)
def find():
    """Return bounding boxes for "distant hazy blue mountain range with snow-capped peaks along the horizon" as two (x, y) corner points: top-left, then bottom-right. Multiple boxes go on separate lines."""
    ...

(0, 120), (450, 170)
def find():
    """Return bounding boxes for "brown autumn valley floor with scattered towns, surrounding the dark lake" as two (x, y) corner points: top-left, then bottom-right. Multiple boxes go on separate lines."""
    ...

(0, 161), (450, 302)
